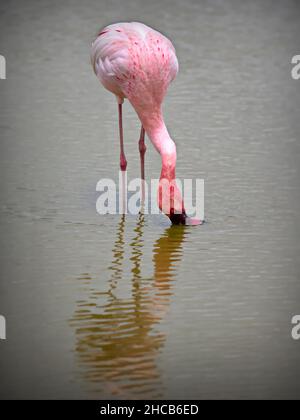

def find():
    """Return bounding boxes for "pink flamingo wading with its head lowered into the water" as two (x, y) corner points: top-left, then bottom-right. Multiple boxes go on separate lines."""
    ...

(91, 22), (201, 225)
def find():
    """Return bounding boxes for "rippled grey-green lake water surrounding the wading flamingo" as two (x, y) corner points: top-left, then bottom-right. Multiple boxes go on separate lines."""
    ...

(0, 0), (300, 399)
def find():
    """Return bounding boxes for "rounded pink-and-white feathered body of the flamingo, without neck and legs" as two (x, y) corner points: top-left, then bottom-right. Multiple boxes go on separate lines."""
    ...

(91, 22), (178, 110)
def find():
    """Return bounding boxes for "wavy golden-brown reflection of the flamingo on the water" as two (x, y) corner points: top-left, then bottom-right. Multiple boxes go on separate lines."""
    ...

(71, 214), (187, 398)
